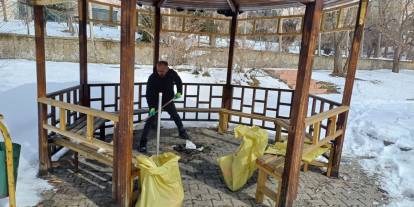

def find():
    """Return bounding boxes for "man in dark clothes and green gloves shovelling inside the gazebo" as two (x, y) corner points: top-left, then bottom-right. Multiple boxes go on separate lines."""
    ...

(139, 61), (190, 152)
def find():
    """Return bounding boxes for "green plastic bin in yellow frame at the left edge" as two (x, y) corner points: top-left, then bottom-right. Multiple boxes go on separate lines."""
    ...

(0, 142), (21, 198)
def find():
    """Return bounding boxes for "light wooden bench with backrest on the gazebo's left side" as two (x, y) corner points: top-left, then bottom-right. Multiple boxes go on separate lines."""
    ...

(38, 98), (139, 201)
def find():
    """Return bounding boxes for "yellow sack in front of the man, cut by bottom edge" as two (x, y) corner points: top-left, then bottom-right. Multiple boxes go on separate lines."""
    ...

(135, 152), (184, 207)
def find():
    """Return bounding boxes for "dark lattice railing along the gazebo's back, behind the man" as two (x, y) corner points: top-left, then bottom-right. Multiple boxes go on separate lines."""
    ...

(89, 83), (294, 130)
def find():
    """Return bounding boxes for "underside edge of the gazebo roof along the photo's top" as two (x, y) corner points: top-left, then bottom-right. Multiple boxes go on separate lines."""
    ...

(29, 0), (358, 11)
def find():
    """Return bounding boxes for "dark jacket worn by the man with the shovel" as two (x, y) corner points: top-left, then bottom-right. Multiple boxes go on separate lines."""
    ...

(146, 69), (183, 108)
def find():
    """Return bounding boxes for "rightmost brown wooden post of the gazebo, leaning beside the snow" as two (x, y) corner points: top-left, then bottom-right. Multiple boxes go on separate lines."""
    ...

(332, 0), (368, 177)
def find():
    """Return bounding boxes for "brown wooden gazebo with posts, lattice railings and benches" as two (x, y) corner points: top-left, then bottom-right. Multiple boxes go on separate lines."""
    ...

(29, 0), (368, 206)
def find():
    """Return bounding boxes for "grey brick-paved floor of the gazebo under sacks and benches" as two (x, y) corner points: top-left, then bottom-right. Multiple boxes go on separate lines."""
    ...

(37, 128), (388, 207)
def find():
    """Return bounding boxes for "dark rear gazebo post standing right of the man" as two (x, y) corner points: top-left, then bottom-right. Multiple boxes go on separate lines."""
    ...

(222, 11), (238, 110)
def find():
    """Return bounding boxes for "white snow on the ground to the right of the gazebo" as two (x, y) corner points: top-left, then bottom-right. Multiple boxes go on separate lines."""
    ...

(312, 70), (414, 206)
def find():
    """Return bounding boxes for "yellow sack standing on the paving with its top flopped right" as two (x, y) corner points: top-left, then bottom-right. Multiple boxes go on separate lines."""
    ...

(217, 125), (268, 191)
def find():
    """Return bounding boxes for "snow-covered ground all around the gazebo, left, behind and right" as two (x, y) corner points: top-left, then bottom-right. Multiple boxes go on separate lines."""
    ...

(0, 60), (414, 206)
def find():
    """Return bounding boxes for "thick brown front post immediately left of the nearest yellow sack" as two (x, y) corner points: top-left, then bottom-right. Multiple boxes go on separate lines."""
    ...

(114, 0), (137, 207)
